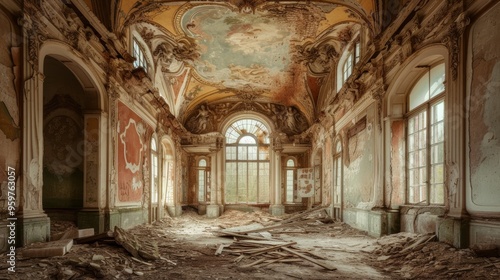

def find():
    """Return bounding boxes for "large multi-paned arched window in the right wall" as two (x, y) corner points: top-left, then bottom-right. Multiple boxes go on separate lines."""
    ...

(407, 63), (445, 205)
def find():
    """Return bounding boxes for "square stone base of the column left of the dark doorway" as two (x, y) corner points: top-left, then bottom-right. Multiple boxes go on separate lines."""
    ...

(15, 214), (50, 247)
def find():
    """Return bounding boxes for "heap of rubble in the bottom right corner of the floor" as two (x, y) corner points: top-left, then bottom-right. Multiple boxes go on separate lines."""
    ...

(373, 232), (500, 279)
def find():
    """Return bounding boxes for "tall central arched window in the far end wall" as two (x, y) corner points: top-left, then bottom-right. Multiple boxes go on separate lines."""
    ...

(225, 119), (269, 204)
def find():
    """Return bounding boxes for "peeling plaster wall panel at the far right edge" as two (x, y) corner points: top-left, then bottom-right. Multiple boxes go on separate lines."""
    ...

(466, 4), (500, 213)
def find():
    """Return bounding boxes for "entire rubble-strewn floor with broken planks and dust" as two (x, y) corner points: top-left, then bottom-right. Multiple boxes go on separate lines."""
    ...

(0, 208), (500, 280)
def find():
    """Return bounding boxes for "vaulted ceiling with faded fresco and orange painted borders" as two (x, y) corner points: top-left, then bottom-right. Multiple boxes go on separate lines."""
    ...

(86, 0), (379, 135)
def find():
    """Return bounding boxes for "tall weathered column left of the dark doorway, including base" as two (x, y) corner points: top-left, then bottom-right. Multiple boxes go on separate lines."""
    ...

(16, 7), (50, 246)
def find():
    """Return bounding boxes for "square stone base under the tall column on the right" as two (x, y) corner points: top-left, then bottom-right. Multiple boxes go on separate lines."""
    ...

(436, 217), (470, 249)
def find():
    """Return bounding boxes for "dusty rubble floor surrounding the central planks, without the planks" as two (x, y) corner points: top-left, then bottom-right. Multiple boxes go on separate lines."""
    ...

(0, 210), (500, 280)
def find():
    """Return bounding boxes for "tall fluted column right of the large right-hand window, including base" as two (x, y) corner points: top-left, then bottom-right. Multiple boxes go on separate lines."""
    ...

(436, 13), (470, 248)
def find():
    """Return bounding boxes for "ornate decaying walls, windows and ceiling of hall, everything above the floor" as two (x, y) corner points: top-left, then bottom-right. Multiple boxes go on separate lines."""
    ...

(0, 0), (500, 274)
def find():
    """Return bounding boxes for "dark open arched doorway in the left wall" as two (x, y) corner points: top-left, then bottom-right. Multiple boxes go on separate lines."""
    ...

(42, 55), (103, 231)
